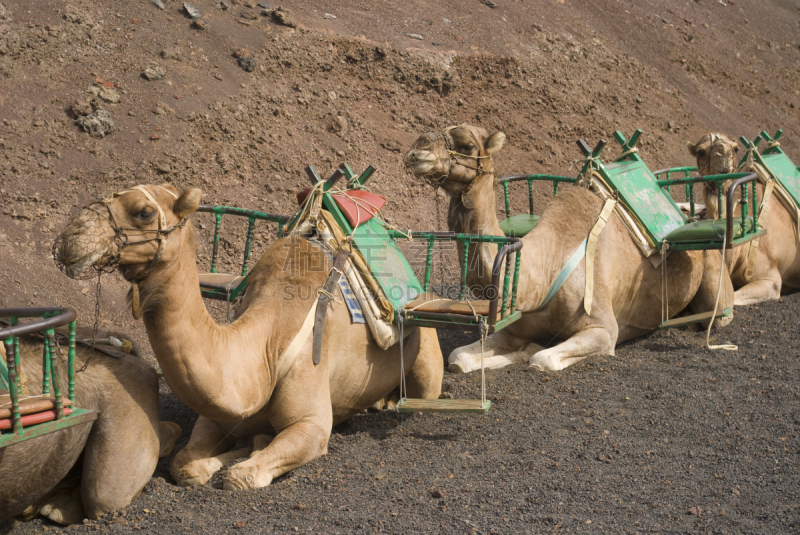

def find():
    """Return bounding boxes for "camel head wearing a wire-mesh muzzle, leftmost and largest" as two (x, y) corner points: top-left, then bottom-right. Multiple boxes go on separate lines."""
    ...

(53, 185), (202, 281)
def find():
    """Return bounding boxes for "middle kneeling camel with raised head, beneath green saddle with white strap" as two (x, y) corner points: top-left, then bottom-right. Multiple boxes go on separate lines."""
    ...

(404, 125), (733, 372)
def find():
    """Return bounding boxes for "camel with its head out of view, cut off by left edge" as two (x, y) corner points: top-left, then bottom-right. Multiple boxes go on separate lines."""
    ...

(0, 327), (181, 524)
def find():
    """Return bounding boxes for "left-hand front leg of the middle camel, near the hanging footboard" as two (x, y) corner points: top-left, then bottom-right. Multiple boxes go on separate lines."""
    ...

(447, 330), (541, 373)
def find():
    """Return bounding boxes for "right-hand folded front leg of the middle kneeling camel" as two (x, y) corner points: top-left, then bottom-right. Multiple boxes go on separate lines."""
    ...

(528, 326), (617, 371)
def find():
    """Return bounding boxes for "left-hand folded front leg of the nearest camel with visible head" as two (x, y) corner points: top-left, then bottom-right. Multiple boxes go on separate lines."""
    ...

(169, 416), (244, 487)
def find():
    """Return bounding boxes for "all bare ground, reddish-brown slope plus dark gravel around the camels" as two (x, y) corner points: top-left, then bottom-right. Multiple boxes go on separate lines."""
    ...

(0, 0), (800, 533)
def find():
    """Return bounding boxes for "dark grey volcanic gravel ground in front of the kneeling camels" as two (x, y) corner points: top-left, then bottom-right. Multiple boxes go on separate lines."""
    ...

(7, 294), (800, 534)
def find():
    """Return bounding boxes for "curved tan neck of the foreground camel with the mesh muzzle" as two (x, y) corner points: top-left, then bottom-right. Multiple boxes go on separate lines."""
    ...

(139, 225), (269, 421)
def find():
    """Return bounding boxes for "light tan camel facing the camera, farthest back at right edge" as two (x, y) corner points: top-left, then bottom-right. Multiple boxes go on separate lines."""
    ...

(688, 133), (800, 305)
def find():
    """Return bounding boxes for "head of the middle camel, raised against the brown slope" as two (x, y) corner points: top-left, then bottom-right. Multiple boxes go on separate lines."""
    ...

(404, 125), (506, 193)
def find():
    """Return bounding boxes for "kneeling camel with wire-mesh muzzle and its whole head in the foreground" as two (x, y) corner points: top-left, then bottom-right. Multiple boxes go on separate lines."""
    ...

(57, 185), (444, 490)
